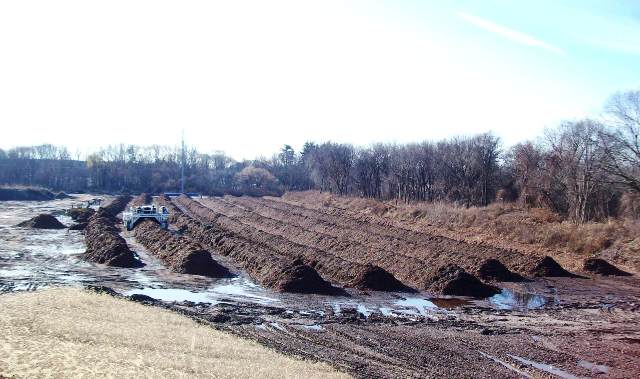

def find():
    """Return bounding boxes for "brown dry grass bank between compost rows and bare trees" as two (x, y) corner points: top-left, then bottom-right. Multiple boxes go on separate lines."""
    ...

(284, 191), (640, 272)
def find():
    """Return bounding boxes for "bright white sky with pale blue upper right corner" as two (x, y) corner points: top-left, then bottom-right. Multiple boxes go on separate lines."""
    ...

(0, 0), (640, 160)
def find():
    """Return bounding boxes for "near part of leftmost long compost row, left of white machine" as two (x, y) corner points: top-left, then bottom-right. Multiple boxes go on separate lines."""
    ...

(83, 208), (144, 267)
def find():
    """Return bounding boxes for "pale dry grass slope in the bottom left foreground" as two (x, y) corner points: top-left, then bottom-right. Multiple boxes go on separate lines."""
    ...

(0, 288), (347, 378)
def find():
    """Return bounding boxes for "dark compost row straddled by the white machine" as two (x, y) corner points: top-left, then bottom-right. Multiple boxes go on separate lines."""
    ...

(131, 194), (232, 278)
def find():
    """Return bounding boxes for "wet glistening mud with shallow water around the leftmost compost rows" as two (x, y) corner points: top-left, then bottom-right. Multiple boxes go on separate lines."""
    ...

(0, 199), (279, 304)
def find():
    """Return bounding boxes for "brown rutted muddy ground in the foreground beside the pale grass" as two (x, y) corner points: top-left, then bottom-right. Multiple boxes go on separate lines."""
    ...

(112, 278), (640, 378)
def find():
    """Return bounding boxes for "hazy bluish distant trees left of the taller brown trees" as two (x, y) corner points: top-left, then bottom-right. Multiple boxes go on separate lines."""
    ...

(0, 145), (283, 195)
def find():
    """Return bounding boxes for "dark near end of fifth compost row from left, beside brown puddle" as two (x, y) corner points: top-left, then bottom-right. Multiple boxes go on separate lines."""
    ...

(427, 264), (500, 298)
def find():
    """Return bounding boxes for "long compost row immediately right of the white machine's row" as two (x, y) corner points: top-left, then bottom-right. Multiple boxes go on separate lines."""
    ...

(158, 196), (345, 295)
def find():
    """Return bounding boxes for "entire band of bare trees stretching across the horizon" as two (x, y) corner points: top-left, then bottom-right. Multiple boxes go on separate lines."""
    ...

(0, 91), (640, 223)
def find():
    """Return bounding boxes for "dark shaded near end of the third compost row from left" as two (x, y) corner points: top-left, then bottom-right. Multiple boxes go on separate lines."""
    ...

(273, 260), (343, 295)
